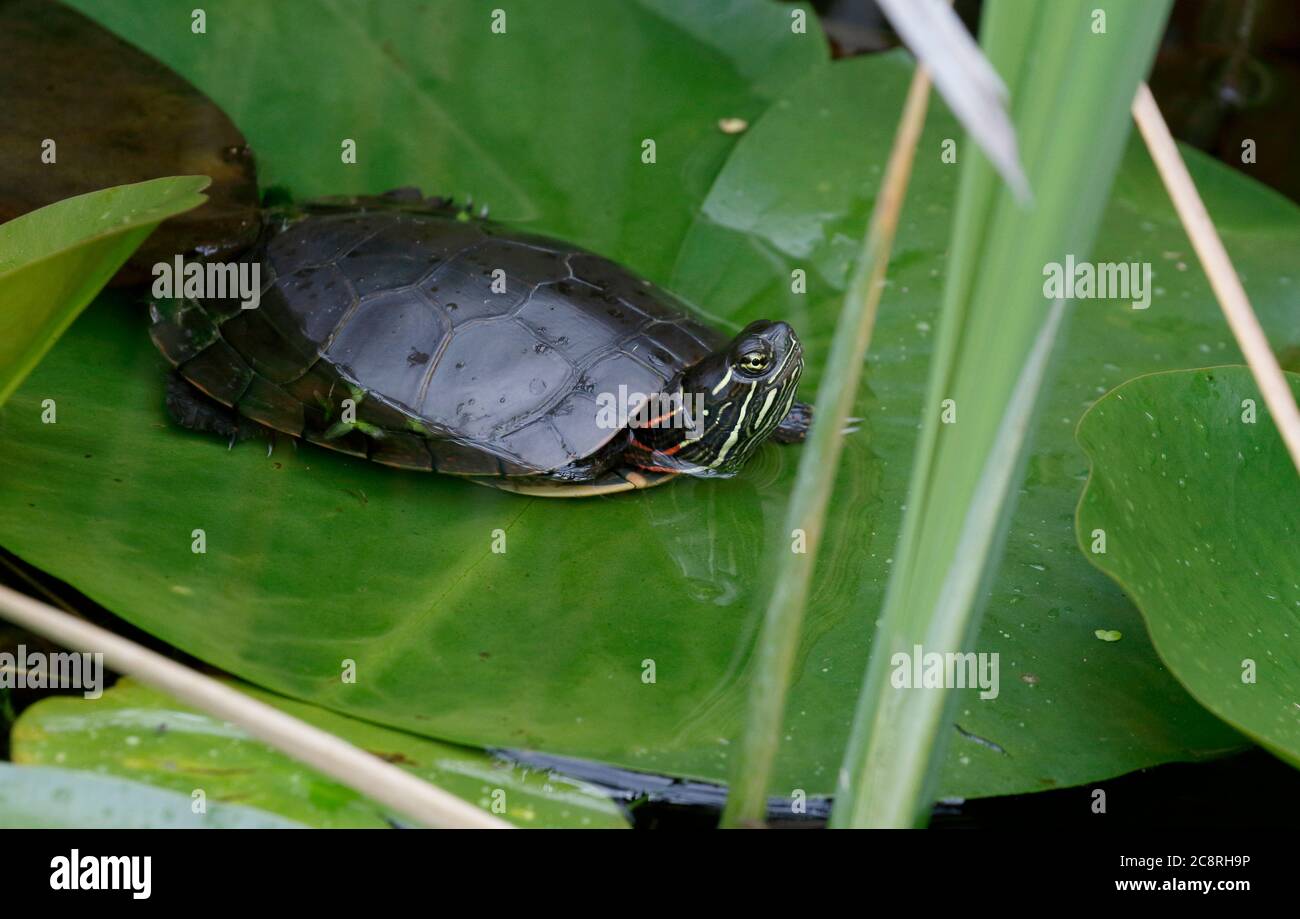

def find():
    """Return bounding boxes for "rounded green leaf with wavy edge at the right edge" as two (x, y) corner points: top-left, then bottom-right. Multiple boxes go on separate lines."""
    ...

(1076, 367), (1300, 766)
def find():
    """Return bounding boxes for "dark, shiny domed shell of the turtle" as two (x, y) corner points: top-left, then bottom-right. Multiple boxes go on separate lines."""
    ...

(152, 197), (722, 477)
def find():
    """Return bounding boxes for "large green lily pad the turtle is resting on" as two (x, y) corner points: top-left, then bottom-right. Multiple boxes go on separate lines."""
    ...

(0, 4), (1300, 797)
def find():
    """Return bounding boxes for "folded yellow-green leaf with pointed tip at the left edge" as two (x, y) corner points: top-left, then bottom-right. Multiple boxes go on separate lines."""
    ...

(0, 175), (208, 406)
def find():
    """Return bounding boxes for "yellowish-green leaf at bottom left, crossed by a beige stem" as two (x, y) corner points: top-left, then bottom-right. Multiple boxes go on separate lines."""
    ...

(12, 680), (627, 828)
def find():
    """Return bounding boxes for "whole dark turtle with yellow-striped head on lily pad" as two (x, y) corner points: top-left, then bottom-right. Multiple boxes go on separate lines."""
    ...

(150, 188), (813, 497)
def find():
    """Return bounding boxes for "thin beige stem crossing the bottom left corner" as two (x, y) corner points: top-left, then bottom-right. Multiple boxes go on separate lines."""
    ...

(0, 586), (510, 829)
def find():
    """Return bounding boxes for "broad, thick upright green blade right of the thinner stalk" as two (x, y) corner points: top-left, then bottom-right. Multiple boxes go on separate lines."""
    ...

(832, 0), (1169, 827)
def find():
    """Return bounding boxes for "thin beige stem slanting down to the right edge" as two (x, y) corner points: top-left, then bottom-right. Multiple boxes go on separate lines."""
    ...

(1134, 83), (1300, 472)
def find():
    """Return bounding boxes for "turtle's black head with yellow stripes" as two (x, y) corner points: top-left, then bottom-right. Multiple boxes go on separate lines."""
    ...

(673, 320), (803, 476)
